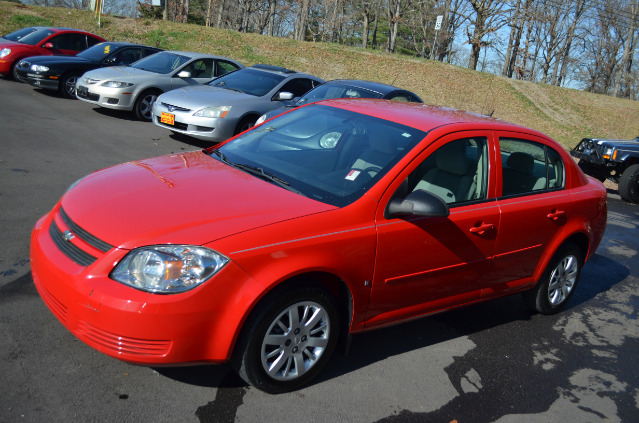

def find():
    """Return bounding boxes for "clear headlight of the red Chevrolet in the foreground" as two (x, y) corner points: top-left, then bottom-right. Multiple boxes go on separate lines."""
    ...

(111, 245), (229, 294)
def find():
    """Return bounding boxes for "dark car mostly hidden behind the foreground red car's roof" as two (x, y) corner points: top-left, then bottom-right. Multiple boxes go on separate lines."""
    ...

(256, 79), (423, 125)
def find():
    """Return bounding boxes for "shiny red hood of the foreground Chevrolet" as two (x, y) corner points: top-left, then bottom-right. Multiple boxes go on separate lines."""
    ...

(62, 151), (335, 249)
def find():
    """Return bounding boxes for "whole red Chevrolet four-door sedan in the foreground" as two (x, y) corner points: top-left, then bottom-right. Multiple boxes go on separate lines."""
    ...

(31, 99), (607, 393)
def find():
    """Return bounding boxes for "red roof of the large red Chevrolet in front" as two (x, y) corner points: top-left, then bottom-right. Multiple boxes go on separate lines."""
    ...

(320, 98), (546, 137)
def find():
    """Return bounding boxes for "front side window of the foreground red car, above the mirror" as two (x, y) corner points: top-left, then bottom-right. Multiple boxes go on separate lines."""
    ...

(408, 137), (488, 205)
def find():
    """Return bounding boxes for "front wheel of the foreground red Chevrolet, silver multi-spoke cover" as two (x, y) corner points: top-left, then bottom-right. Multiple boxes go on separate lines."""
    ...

(233, 285), (340, 394)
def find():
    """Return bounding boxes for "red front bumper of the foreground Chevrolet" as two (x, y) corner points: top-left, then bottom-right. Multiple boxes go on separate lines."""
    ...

(31, 209), (254, 365)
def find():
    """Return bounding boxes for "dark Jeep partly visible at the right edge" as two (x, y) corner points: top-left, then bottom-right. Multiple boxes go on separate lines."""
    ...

(570, 137), (639, 203)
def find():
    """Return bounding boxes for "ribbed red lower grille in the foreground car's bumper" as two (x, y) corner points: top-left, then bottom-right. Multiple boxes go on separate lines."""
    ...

(78, 321), (171, 357)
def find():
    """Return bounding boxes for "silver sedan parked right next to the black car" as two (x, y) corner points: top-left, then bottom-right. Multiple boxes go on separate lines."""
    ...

(76, 51), (244, 120)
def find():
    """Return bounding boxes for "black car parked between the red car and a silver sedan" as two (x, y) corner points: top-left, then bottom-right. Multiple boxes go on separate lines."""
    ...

(16, 42), (162, 98)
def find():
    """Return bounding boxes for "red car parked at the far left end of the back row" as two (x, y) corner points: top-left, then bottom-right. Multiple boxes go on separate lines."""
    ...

(0, 28), (105, 79)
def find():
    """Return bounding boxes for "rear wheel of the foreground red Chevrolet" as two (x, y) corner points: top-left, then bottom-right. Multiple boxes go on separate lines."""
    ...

(524, 244), (583, 314)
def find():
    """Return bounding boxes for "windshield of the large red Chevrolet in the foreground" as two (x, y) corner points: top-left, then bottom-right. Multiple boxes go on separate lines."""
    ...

(210, 105), (426, 207)
